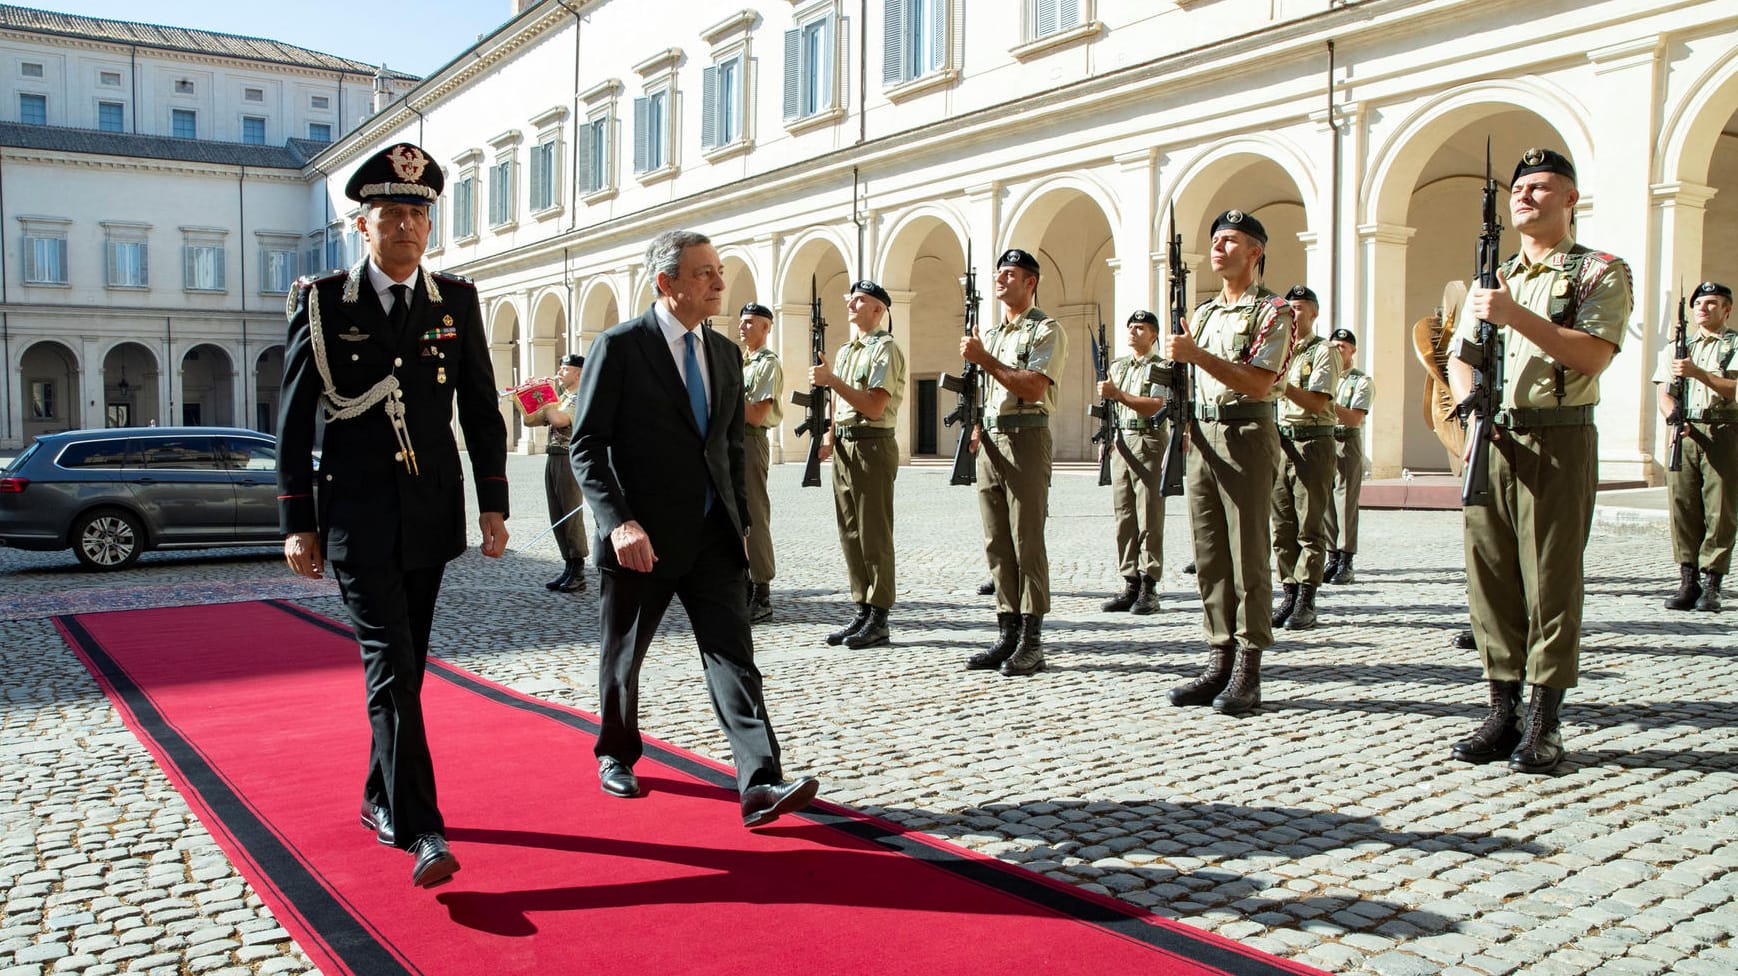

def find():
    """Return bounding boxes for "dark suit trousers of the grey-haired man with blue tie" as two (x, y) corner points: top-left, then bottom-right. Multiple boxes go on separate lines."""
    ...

(594, 505), (784, 790)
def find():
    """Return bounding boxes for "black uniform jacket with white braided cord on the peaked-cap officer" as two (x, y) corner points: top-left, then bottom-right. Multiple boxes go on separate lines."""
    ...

(278, 262), (507, 570)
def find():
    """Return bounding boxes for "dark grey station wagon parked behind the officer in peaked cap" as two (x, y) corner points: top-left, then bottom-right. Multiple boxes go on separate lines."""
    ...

(0, 427), (283, 570)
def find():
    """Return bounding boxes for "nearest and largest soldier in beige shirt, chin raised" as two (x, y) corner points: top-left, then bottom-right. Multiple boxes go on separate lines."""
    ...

(1448, 149), (1632, 773)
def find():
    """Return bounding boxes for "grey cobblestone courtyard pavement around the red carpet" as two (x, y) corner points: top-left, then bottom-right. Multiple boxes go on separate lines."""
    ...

(0, 458), (1738, 976)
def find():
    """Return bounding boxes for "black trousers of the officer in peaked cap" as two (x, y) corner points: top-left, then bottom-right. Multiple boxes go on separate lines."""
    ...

(332, 563), (447, 847)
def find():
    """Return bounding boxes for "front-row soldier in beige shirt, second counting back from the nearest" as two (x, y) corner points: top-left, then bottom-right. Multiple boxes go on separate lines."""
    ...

(1159, 210), (1291, 716)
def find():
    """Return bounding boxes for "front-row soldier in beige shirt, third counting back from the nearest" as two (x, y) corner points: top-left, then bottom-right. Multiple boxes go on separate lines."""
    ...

(959, 248), (1069, 677)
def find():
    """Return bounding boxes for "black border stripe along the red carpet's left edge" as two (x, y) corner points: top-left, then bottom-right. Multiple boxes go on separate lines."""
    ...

(54, 601), (421, 976)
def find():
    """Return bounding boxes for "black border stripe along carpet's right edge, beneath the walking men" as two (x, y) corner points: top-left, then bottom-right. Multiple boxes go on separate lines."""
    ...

(264, 599), (1314, 976)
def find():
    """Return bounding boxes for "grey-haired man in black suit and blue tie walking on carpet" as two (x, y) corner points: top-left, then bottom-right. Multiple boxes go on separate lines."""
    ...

(568, 231), (819, 827)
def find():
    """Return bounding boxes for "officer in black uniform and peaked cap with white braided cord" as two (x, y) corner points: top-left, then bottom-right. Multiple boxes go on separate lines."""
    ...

(278, 142), (507, 887)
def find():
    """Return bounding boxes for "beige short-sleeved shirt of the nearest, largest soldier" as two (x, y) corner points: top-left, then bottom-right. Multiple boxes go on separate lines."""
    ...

(1455, 238), (1634, 408)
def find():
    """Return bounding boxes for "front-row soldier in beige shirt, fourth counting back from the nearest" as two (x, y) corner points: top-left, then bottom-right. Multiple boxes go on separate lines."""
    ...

(808, 281), (905, 648)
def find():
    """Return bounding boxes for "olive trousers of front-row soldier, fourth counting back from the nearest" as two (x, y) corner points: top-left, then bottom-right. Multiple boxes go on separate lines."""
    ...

(833, 438), (899, 610)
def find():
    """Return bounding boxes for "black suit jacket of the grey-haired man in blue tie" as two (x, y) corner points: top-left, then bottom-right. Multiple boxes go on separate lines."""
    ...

(568, 309), (749, 577)
